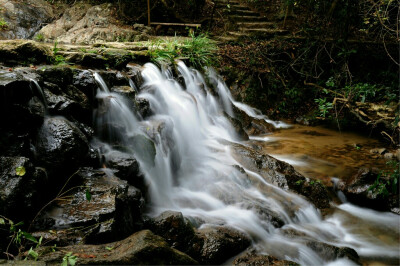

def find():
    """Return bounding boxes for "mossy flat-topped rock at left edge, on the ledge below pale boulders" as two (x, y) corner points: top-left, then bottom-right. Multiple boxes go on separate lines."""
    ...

(0, 40), (51, 65)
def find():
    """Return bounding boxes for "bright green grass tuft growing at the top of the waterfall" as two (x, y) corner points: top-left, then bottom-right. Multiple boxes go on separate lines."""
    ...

(148, 33), (218, 68)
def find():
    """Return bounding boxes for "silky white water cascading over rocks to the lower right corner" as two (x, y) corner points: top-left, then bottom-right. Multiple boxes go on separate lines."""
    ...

(95, 62), (399, 265)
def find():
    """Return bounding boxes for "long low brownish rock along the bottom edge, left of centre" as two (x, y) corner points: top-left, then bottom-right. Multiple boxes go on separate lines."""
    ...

(36, 230), (197, 265)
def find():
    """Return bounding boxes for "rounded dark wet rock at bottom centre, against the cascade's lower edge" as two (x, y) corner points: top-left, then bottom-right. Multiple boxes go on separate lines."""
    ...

(197, 226), (251, 265)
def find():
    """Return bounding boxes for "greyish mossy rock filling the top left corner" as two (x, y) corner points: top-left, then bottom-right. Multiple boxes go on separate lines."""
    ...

(0, 0), (54, 40)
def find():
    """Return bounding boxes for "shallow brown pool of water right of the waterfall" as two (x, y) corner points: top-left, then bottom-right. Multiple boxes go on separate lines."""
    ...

(247, 125), (387, 186)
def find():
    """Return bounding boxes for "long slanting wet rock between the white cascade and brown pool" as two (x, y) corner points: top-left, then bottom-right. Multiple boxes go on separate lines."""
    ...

(232, 144), (330, 209)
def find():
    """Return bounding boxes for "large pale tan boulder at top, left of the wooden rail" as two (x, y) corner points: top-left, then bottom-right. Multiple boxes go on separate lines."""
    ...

(39, 4), (151, 43)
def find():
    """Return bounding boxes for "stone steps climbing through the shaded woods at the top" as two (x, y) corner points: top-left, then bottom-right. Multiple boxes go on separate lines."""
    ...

(215, 0), (288, 42)
